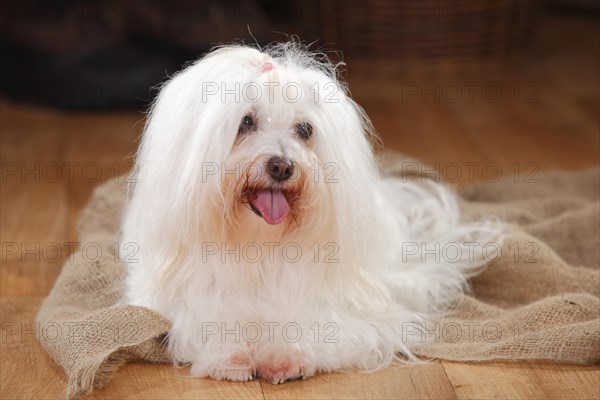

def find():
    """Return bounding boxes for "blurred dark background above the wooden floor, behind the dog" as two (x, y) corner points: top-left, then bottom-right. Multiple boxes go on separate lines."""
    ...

(0, 0), (600, 110)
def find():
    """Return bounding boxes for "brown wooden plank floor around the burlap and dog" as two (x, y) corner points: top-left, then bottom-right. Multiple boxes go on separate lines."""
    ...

(0, 14), (600, 399)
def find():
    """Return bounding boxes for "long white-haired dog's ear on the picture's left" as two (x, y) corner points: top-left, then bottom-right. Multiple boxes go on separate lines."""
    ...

(128, 47), (256, 241)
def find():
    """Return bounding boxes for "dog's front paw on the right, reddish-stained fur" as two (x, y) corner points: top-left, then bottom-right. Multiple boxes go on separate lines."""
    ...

(257, 351), (313, 385)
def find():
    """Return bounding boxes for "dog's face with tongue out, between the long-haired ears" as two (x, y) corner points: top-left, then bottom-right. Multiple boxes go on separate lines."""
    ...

(217, 56), (325, 226)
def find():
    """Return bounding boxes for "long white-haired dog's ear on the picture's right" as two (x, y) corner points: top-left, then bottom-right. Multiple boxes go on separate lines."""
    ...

(296, 76), (391, 270)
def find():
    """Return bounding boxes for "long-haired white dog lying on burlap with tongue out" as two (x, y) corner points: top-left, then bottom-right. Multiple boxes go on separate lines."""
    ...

(122, 43), (498, 383)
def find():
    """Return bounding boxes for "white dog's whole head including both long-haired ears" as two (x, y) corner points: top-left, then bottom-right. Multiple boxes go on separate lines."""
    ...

(136, 43), (376, 239)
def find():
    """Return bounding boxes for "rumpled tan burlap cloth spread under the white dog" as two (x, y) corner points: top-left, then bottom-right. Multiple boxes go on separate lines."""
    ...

(37, 157), (600, 397)
